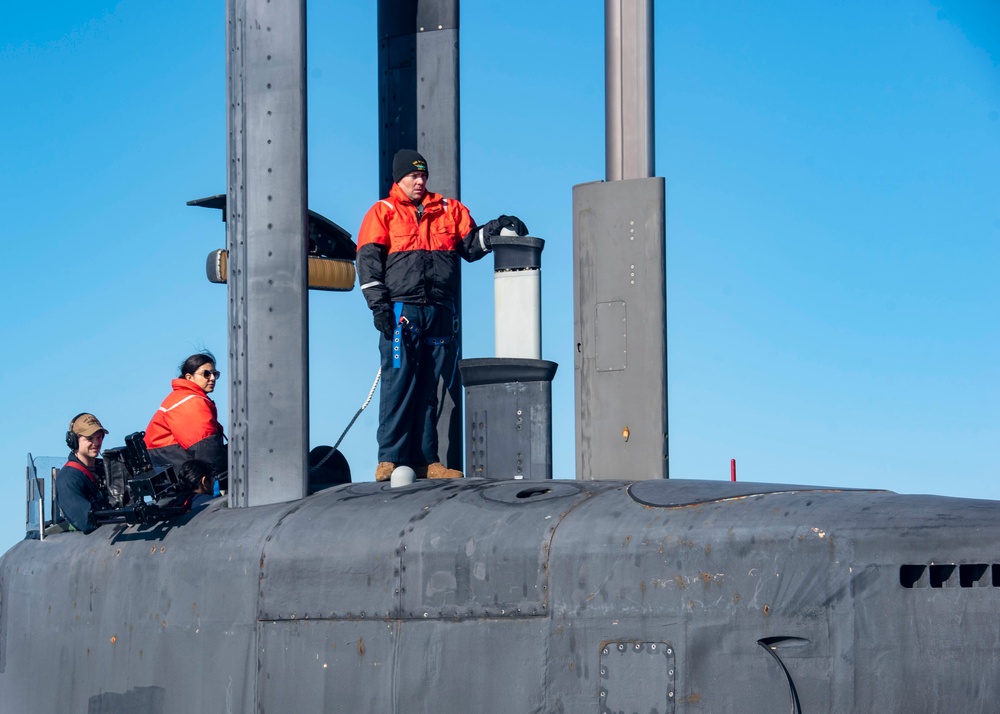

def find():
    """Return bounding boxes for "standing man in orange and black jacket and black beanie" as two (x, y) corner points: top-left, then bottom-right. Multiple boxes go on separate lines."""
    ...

(357, 149), (528, 481)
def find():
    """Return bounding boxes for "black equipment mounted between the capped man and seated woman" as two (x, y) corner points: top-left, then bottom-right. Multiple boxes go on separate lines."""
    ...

(93, 431), (188, 525)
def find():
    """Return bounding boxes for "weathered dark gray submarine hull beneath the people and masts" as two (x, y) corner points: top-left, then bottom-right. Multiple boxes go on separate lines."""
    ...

(0, 479), (1000, 714)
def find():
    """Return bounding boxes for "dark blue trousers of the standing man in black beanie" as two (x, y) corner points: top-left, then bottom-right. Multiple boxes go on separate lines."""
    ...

(377, 303), (458, 466)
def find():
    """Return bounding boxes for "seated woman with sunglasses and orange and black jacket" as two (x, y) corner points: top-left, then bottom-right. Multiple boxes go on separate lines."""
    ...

(145, 350), (229, 480)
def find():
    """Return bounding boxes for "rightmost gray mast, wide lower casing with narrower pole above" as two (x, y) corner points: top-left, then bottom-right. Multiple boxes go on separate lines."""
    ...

(573, 0), (669, 480)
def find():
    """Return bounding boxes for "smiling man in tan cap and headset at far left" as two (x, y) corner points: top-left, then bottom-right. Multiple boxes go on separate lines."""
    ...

(56, 412), (111, 533)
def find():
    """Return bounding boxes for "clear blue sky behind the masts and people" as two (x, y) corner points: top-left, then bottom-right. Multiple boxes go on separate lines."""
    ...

(0, 0), (1000, 551)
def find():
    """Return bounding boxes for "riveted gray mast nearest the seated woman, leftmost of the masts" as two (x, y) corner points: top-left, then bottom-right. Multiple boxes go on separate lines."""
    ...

(226, 0), (309, 506)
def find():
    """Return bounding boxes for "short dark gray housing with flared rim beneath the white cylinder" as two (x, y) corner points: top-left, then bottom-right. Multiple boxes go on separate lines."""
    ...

(458, 359), (558, 480)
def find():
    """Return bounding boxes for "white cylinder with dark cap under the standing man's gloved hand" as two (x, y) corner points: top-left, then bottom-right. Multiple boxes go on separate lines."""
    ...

(492, 235), (545, 360)
